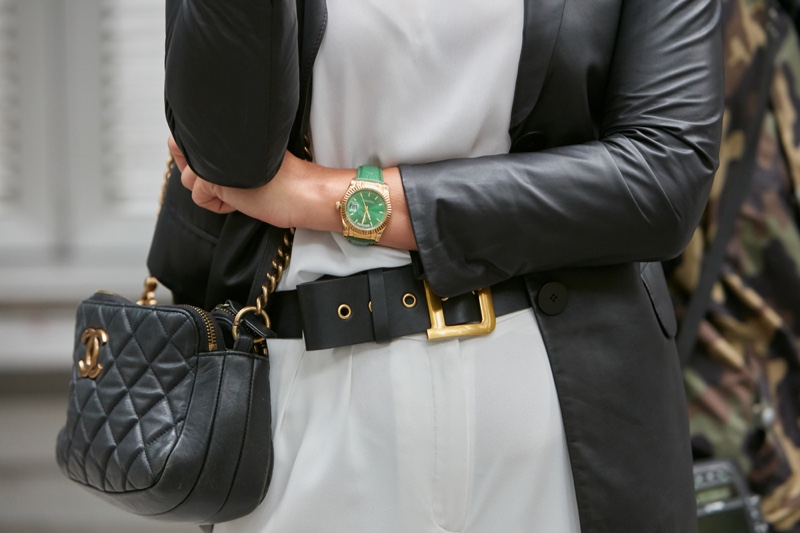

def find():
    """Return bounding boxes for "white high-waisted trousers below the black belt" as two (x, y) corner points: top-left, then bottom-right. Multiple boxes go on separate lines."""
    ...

(214, 309), (580, 533)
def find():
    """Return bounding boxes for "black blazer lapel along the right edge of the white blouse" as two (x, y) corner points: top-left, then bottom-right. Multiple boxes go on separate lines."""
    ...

(509, 0), (566, 137)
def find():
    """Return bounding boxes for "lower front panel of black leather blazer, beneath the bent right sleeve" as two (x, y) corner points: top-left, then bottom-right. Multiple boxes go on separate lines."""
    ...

(525, 263), (697, 533)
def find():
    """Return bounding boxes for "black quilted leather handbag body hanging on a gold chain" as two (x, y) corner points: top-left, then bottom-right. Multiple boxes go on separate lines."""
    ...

(56, 293), (272, 523)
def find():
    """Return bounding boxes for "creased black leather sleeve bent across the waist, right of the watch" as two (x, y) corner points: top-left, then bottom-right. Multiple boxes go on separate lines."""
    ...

(400, 0), (723, 296)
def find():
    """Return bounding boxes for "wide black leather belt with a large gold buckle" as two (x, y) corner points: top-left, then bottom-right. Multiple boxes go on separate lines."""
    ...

(268, 266), (531, 350)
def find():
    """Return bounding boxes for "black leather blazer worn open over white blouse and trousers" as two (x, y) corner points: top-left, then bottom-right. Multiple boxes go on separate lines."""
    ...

(148, 0), (723, 533)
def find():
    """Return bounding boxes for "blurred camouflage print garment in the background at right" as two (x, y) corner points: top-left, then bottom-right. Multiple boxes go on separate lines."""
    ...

(667, 0), (800, 533)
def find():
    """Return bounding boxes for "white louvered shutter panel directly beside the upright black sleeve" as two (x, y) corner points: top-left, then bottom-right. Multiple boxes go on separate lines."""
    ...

(100, 0), (169, 215)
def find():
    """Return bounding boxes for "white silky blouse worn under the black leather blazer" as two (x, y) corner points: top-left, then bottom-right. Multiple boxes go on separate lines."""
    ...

(280, 0), (524, 290)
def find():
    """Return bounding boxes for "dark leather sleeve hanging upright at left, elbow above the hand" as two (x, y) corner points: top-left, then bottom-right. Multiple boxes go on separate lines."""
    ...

(165, 0), (299, 187)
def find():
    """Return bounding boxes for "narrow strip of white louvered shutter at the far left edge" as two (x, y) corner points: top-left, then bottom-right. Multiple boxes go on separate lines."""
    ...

(0, 0), (20, 212)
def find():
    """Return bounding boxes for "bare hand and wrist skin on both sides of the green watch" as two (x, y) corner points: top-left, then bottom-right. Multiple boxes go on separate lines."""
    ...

(168, 136), (416, 250)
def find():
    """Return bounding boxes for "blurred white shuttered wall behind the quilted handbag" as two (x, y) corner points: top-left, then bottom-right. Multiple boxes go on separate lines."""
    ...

(0, 0), (198, 533)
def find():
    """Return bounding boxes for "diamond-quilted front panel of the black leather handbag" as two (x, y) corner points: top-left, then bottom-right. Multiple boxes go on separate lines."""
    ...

(58, 299), (201, 492)
